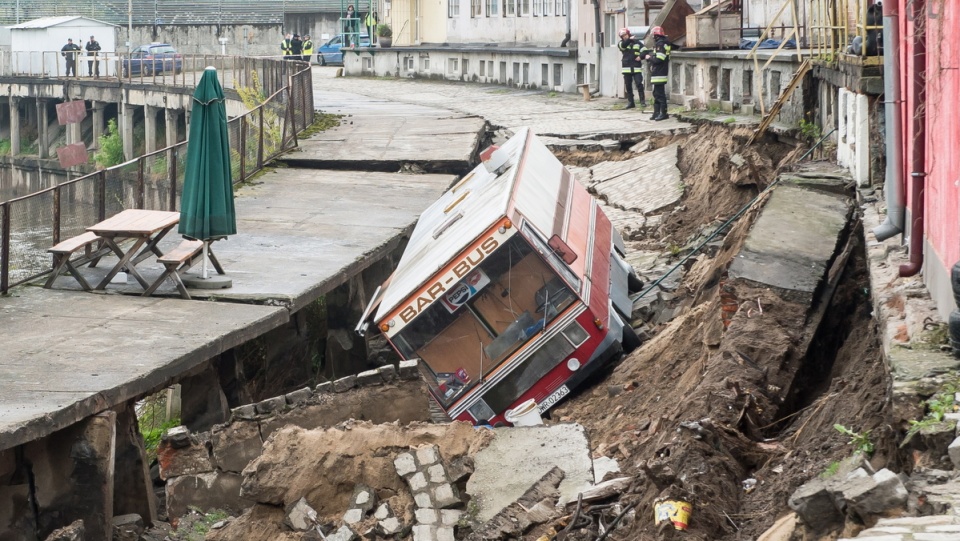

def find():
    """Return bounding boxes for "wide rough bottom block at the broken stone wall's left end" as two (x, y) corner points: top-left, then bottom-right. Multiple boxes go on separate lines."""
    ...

(167, 472), (253, 523)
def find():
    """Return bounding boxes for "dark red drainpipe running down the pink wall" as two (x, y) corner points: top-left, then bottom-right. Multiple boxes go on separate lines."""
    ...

(900, 0), (927, 277)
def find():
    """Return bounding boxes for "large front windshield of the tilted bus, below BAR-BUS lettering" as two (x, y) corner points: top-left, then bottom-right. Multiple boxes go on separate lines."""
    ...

(391, 234), (577, 407)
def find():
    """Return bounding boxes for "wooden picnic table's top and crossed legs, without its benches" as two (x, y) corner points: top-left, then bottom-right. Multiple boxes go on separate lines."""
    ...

(87, 209), (180, 290)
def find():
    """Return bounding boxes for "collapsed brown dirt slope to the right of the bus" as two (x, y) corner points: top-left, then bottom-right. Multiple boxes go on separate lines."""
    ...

(553, 126), (895, 540)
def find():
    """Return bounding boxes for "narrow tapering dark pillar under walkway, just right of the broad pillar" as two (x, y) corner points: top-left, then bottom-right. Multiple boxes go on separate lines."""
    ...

(113, 402), (157, 524)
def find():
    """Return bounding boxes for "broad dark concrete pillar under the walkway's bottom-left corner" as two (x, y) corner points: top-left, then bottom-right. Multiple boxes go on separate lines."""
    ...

(24, 411), (117, 541)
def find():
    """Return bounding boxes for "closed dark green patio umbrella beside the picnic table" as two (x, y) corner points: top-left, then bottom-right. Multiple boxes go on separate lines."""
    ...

(178, 67), (237, 279)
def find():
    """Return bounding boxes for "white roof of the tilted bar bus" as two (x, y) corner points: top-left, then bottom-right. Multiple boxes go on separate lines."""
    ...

(374, 128), (533, 322)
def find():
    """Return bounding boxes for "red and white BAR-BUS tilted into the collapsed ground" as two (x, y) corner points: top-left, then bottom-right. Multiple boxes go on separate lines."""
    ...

(358, 129), (639, 425)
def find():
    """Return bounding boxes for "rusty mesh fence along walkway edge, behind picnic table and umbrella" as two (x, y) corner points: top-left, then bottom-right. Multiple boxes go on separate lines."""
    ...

(0, 57), (314, 294)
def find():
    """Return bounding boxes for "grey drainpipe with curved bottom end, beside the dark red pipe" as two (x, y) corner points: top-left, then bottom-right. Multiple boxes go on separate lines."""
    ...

(873, 1), (904, 241)
